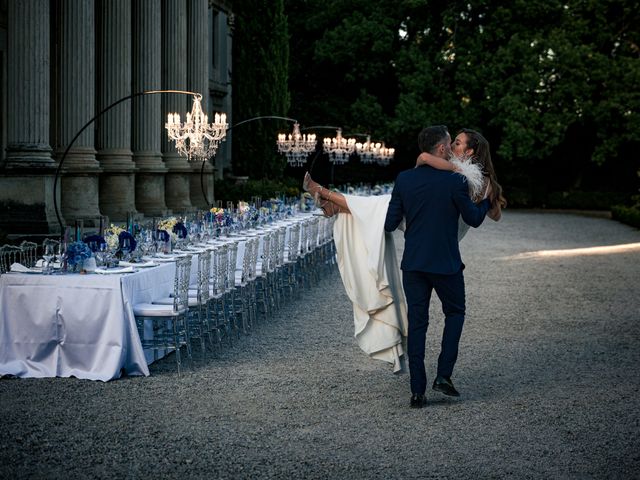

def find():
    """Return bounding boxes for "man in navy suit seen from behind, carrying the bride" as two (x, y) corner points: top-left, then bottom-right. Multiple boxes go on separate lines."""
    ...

(384, 125), (491, 408)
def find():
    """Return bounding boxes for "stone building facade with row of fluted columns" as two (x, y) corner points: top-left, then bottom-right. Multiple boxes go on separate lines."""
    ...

(0, 0), (233, 234)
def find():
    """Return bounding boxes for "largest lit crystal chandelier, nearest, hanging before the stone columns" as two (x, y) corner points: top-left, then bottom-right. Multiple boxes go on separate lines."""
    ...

(165, 94), (228, 162)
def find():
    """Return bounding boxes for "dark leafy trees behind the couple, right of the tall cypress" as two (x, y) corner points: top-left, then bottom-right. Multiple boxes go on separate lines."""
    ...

(286, 0), (640, 199)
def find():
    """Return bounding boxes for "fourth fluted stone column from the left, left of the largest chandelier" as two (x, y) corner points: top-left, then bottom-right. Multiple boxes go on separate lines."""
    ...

(131, 0), (169, 216)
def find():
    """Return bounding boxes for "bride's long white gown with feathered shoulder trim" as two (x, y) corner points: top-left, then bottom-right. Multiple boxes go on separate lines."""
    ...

(333, 159), (482, 372)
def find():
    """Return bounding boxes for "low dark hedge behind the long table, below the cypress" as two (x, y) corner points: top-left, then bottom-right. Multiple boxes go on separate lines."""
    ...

(215, 177), (302, 205)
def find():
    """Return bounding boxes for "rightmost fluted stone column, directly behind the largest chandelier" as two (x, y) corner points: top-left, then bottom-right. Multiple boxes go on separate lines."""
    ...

(187, 0), (213, 210)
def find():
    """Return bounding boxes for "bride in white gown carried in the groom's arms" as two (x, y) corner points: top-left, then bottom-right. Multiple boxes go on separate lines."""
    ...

(303, 129), (506, 372)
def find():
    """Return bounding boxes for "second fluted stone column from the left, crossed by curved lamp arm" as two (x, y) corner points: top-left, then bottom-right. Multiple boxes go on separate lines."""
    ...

(54, 0), (101, 226)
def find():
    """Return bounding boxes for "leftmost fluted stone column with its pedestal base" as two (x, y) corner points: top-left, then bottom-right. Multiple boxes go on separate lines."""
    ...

(0, 0), (59, 233)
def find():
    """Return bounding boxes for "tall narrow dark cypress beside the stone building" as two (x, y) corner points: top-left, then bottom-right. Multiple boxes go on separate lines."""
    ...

(230, 0), (290, 179)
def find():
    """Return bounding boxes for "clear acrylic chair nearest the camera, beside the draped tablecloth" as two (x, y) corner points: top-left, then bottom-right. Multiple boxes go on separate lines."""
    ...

(133, 255), (191, 374)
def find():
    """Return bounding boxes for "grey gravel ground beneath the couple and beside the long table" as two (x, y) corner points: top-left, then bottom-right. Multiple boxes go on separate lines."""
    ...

(0, 210), (640, 479)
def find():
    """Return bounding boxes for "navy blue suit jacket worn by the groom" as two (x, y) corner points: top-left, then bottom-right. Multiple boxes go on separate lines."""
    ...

(384, 165), (491, 275)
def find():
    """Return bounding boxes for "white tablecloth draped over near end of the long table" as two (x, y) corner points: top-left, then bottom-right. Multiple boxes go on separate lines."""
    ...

(0, 263), (175, 381)
